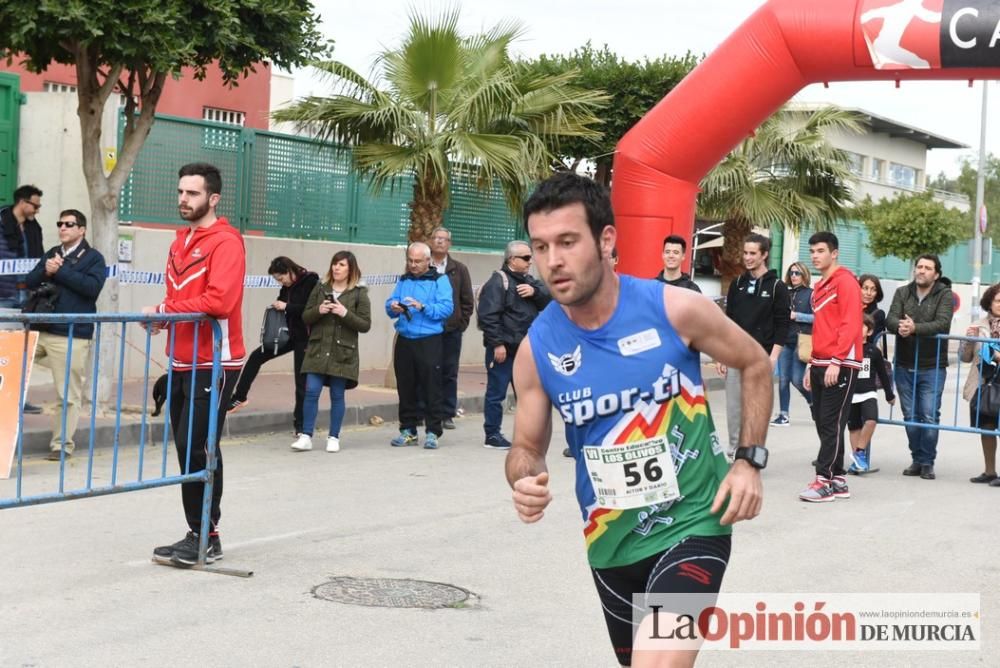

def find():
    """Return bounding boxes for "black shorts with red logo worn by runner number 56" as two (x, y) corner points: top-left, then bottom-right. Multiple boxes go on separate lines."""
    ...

(591, 536), (731, 666)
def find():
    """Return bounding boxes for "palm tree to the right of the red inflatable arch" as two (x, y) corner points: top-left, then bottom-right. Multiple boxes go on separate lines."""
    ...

(698, 107), (863, 294)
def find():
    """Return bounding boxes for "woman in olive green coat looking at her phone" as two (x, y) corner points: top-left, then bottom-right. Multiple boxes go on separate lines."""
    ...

(292, 251), (372, 452)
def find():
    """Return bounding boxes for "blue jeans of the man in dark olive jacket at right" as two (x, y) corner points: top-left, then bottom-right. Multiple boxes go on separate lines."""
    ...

(893, 365), (947, 465)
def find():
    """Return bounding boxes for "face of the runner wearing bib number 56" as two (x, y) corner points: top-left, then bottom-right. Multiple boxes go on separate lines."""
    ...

(528, 203), (615, 306)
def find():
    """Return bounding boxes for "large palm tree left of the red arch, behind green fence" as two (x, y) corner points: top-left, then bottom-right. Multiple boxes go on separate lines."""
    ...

(274, 10), (606, 240)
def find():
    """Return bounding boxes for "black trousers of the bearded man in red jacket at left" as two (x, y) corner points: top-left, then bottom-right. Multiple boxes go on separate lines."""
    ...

(170, 369), (239, 534)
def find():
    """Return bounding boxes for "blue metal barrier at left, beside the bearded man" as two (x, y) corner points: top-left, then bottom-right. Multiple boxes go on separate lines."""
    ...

(0, 313), (222, 567)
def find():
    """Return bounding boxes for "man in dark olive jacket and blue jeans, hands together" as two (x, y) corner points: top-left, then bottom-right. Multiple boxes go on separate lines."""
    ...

(885, 254), (954, 480)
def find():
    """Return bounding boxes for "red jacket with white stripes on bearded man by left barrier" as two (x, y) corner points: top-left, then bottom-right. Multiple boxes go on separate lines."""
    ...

(158, 218), (246, 370)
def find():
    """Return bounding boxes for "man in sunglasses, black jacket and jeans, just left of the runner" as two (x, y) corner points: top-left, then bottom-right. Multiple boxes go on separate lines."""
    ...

(476, 241), (552, 450)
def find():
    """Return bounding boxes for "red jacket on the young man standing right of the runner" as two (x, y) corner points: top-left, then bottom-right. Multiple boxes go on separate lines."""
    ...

(811, 267), (864, 369)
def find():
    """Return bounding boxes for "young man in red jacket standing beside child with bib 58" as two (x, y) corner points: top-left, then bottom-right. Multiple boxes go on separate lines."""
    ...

(799, 232), (864, 503)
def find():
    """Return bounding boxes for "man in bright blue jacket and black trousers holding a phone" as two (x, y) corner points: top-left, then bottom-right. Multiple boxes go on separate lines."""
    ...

(385, 241), (454, 450)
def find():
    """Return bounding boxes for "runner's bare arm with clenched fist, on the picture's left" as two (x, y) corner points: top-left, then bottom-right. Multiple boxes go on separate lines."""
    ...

(506, 337), (552, 524)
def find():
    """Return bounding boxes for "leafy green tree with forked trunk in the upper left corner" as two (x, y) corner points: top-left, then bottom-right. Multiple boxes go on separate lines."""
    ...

(0, 0), (323, 400)
